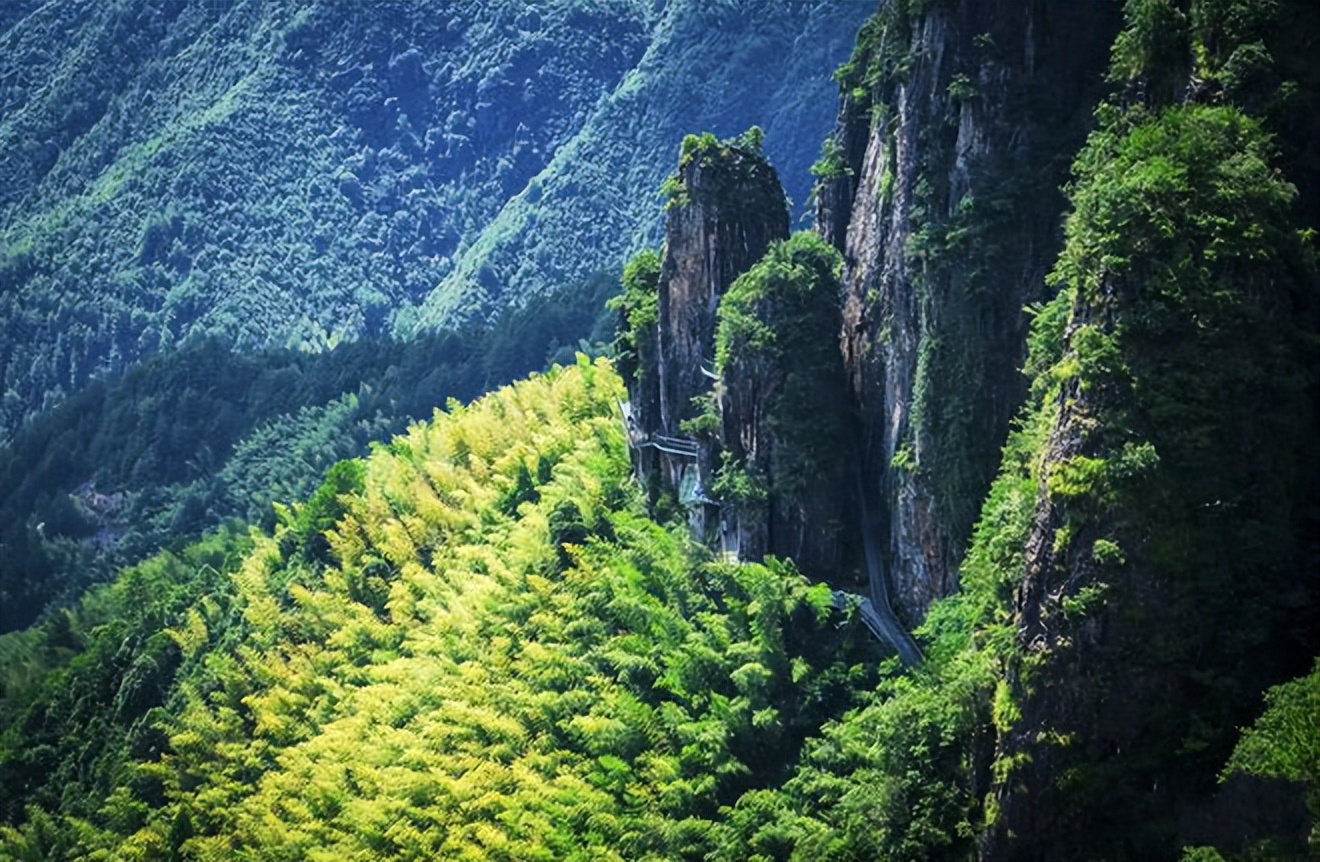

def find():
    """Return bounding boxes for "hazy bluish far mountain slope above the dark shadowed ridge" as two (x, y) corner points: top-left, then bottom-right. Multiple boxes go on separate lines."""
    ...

(0, 0), (870, 432)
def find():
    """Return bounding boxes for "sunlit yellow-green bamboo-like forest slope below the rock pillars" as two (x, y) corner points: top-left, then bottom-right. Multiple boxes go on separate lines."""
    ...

(0, 360), (874, 859)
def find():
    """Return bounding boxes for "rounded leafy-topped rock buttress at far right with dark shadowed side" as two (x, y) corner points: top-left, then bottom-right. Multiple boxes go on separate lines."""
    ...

(997, 94), (1316, 855)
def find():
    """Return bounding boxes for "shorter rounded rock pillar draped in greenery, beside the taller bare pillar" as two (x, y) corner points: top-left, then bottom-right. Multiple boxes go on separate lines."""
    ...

(713, 231), (859, 586)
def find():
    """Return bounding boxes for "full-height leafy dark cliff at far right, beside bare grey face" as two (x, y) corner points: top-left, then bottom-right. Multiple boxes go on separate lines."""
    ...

(981, 3), (1320, 859)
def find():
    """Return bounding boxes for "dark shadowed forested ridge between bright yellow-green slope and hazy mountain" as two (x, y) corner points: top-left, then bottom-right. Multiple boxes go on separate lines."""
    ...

(0, 271), (616, 631)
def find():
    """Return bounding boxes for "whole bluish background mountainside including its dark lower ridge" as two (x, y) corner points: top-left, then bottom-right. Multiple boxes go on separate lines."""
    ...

(0, 0), (869, 630)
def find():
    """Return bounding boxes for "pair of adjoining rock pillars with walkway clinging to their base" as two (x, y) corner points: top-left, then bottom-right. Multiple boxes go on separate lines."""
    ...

(615, 135), (857, 583)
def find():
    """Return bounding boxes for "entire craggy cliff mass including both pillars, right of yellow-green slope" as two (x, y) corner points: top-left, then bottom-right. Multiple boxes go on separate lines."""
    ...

(583, 1), (1320, 859)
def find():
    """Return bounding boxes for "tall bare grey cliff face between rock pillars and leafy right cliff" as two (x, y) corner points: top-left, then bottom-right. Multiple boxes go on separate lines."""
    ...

(817, 0), (1117, 619)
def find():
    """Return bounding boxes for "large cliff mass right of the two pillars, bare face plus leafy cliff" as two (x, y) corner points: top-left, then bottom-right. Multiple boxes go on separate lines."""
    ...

(788, 1), (1320, 859)
